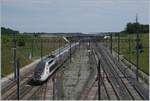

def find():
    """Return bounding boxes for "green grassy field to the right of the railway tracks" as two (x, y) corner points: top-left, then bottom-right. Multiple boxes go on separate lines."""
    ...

(113, 34), (149, 75)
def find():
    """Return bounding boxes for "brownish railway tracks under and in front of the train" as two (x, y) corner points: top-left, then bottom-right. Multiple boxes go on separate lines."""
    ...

(2, 56), (70, 100)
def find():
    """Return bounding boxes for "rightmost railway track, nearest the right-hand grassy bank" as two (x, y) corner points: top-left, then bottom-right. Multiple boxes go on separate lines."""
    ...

(103, 44), (149, 99)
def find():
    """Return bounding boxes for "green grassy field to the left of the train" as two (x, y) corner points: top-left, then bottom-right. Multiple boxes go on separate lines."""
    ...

(1, 35), (66, 77)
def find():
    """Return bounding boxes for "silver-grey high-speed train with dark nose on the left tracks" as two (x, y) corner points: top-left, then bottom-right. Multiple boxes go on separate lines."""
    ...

(32, 42), (79, 82)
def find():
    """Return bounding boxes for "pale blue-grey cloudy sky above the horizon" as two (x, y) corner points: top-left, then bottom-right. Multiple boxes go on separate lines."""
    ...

(1, 0), (149, 33)
